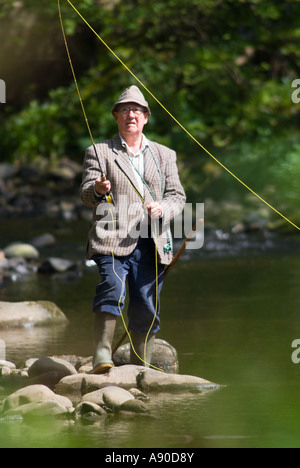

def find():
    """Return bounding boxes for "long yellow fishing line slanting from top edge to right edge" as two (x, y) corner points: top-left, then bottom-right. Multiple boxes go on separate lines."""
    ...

(67, 0), (300, 231)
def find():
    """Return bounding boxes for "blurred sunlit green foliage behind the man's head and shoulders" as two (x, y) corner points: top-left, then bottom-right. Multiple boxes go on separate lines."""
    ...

(0, 0), (300, 221)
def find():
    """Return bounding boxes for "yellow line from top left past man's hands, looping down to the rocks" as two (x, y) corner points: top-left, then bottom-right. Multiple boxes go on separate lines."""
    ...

(57, 0), (164, 372)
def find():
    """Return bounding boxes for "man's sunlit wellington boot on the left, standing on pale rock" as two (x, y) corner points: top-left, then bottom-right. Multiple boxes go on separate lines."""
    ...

(91, 313), (117, 374)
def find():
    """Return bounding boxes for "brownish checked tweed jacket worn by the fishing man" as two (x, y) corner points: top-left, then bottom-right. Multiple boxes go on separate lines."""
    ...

(80, 135), (186, 265)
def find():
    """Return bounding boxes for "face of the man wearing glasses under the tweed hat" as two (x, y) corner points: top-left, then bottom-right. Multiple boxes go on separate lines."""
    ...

(114, 103), (148, 137)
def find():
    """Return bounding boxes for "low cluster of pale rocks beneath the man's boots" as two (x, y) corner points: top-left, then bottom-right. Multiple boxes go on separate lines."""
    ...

(0, 356), (220, 423)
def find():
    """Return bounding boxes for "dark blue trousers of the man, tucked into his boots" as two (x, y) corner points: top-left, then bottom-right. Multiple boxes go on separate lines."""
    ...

(93, 238), (164, 334)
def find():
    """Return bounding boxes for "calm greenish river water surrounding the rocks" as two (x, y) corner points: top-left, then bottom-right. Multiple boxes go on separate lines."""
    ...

(0, 222), (300, 448)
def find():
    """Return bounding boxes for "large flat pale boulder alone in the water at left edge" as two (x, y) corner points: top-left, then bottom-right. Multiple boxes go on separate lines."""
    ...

(0, 301), (68, 329)
